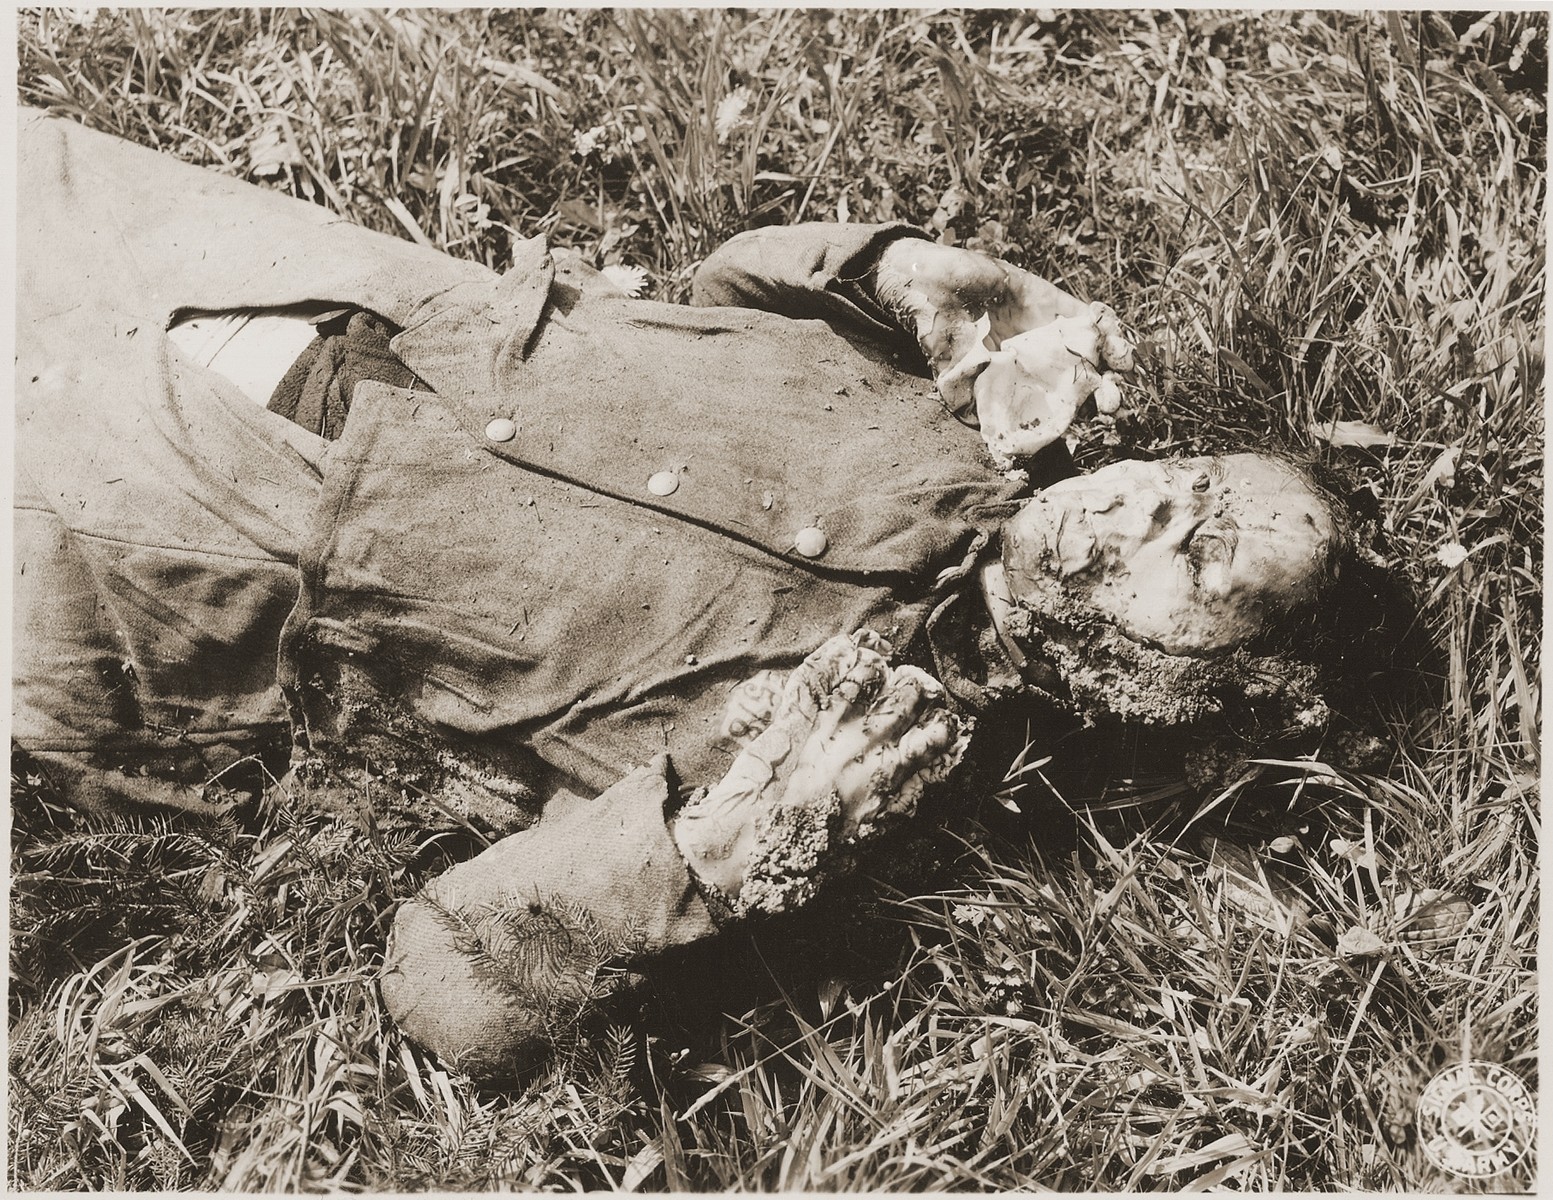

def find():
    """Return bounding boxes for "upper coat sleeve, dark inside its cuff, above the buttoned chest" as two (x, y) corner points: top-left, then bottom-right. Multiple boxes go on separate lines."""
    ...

(691, 222), (927, 354)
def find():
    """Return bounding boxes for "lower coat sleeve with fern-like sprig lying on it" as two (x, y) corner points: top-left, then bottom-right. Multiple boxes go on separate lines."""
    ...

(382, 756), (717, 1079)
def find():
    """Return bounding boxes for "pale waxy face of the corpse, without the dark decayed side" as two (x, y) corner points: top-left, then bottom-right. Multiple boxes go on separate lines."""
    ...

(1003, 455), (1334, 654)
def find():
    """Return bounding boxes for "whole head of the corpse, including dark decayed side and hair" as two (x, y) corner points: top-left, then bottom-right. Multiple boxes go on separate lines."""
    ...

(1000, 453), (1429, 744)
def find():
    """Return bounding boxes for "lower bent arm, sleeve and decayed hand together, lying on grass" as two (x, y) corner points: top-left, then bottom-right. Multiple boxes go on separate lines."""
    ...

(382, 632), (969, 1077)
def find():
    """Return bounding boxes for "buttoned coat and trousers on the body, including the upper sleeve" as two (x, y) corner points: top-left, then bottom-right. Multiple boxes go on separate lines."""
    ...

(14, 112), (1016, 806)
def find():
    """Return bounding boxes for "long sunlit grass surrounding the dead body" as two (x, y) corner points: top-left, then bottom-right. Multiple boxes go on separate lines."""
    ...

(9, 9), (1547, 1191)
